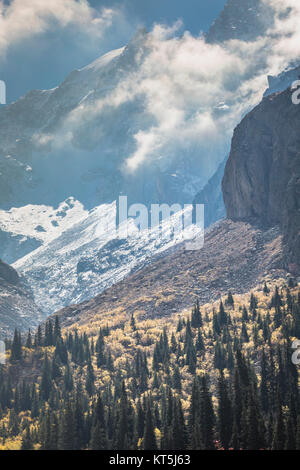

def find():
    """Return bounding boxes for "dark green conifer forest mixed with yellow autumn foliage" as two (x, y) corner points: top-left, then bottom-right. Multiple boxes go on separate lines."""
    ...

(0, 279), (300, 450)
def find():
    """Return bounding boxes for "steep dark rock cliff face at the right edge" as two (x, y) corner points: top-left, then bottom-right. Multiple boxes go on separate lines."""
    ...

(222, 89), (300, 272)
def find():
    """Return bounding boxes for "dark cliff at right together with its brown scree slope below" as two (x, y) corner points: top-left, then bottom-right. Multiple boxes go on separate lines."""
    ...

(52, 67), (300, 324)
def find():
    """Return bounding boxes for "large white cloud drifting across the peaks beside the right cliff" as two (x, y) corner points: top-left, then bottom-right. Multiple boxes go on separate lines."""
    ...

(30, 0), (300, 182)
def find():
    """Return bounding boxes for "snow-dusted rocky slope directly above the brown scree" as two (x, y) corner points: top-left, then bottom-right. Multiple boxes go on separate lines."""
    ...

(14, 203), (201, 314)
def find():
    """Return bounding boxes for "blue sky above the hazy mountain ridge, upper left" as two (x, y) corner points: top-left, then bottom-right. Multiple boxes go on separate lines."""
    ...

(0, 0), (226, 102)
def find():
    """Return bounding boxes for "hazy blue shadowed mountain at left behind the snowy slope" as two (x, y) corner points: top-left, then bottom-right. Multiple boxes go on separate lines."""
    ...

(0, 30), (206, 213)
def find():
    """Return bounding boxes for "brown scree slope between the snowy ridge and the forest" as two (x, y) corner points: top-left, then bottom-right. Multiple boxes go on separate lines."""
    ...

(58, 220), (285, 326)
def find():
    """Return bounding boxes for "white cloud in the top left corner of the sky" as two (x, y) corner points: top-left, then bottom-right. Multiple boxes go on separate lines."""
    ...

(0, 0), (117, 54)
